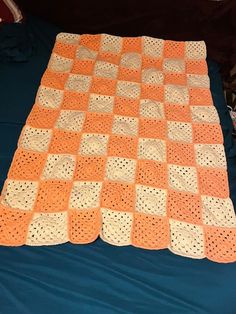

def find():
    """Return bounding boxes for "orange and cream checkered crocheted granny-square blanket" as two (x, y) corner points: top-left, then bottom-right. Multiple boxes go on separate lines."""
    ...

(0, 33), (236, 262)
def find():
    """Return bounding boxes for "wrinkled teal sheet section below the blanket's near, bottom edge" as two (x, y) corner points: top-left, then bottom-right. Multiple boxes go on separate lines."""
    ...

(0, 240), (236, 314)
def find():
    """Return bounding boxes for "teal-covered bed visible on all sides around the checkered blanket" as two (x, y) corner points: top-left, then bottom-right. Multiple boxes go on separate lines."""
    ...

(0, 17), (236, 314)
